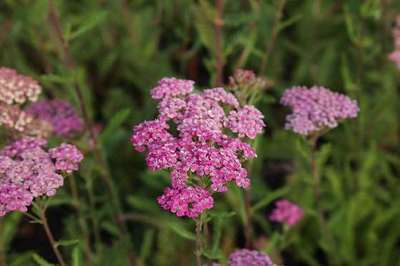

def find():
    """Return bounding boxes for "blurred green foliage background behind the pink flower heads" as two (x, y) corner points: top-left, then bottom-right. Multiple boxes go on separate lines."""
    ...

(0, 0), (400, 266)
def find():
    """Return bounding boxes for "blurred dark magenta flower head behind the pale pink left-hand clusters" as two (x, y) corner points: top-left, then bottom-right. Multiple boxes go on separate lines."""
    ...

(25, 99), (83, 137)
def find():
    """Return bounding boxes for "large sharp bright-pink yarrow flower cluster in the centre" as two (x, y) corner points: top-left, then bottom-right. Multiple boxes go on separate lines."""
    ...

(131, 78), (265, 218)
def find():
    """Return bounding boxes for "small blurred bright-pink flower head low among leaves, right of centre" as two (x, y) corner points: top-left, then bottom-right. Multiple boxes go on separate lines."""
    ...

(269, 199), (304, 226)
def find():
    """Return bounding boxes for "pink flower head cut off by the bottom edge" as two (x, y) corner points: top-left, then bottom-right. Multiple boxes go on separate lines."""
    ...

(228, 249), (274, 266)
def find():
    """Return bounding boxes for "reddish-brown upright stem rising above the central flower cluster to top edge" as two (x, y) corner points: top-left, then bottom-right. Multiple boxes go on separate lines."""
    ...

(214, 0), (224, 86)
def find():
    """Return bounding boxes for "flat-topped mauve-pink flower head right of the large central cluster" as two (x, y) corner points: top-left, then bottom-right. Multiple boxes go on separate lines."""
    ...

(281, 86), (359, 135)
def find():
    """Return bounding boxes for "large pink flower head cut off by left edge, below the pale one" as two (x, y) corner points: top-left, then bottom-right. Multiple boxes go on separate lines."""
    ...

(0, 137), (83, 216)
